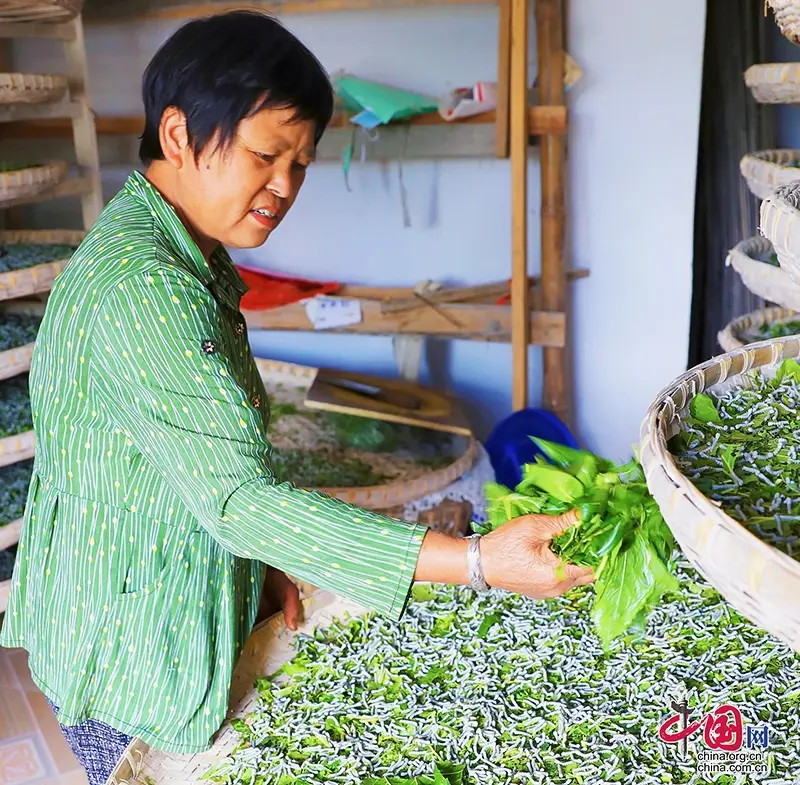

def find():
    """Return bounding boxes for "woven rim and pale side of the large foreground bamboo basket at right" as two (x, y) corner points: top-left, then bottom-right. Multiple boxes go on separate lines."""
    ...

(640, 337), (800, 653)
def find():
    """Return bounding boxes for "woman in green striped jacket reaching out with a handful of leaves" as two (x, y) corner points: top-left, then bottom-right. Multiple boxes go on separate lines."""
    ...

(2, 12), (592, 783)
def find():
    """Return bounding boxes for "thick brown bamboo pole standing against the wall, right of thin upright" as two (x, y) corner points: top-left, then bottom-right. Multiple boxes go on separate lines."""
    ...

(536, 0), (570, 421)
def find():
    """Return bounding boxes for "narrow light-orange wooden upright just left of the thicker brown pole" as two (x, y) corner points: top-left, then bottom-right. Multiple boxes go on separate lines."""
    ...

(509, 0), (531, 411)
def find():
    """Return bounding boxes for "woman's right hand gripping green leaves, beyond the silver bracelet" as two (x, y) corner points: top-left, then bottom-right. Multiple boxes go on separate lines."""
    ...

(480, 510), (594, 599)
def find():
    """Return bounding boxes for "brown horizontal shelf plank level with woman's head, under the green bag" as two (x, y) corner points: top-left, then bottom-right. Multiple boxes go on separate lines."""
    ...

(0, 106), (567, 139)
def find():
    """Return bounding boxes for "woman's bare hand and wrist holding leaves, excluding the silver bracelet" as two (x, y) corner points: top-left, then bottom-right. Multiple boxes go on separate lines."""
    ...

(414, 511), (594, 599)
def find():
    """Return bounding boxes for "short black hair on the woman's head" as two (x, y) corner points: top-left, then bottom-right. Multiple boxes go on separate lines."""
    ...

(139, 11), (334, 166)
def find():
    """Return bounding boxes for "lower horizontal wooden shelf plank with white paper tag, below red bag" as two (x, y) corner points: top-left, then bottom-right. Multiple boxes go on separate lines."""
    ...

(243, 300), (565, 346)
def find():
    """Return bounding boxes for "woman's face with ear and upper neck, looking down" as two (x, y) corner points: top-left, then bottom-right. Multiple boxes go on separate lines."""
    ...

(167, 109), (315, 253)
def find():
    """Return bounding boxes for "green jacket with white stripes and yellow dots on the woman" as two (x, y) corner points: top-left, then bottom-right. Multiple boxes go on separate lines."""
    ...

(0, 173), (424, 753)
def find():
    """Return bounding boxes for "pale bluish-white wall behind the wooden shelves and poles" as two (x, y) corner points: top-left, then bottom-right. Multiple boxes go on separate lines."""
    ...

(9, 0), (704, 458)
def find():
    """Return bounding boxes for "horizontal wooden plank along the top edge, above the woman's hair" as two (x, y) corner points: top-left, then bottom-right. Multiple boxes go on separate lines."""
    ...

(83, 0), (493, 24)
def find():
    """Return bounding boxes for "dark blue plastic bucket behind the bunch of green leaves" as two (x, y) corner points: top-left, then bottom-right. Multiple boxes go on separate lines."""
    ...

(485, 409), (578, 488)
